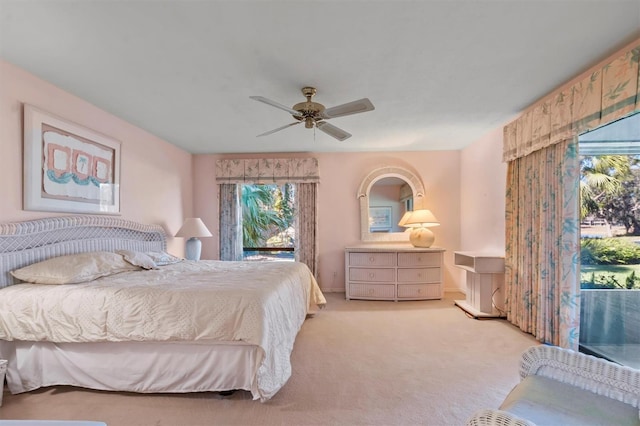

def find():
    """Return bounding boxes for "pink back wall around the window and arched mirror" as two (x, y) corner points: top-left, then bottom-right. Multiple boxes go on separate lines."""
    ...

(194, 151), (461, 291)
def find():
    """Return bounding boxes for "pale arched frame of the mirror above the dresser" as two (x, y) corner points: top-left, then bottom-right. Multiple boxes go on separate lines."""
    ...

(357, 166), (424, 242)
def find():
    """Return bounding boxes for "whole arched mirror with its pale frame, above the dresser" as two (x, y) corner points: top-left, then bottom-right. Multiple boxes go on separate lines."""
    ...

(358, 167), (424, 242)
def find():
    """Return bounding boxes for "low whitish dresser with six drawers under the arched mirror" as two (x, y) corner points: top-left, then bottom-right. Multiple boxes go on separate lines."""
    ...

(345, 244), (444, 301)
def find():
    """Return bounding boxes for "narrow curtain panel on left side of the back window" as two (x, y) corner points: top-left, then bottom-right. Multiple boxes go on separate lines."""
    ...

(219, 183), (242, 260)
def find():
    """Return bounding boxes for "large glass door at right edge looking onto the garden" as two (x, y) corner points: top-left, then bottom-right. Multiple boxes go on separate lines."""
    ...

(579, 114), (640, 368)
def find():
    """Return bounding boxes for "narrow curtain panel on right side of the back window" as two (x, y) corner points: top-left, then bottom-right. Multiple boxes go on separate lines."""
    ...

(295, 183), (318, 276)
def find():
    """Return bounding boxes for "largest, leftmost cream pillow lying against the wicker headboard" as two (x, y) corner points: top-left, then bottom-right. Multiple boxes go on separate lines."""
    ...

(11, 251), (140, 284)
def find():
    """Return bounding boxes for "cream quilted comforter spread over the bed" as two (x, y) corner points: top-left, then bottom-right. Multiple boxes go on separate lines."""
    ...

(0, 261), (326, 398)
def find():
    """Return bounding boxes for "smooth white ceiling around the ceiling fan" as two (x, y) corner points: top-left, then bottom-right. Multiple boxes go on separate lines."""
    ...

(0, 0), (640, 153)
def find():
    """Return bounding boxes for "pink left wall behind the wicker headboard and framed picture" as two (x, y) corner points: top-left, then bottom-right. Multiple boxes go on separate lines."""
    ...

(0, 61), (193, 255)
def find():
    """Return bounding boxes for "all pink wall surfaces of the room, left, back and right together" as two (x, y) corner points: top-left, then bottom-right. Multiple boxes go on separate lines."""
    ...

(0, 61), (480, 291)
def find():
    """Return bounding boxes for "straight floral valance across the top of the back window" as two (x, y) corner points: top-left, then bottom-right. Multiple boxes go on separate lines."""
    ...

(216, 158), (320, 184)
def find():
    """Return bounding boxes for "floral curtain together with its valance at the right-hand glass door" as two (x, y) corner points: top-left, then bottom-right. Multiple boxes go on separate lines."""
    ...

(503, 39), (640, 350)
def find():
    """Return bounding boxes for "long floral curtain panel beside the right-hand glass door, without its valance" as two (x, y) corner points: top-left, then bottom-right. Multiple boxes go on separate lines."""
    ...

(505, 139), (580, 350)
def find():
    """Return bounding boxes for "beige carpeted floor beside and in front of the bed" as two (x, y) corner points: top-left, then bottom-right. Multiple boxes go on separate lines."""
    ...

(0, 293), (538, 426)
